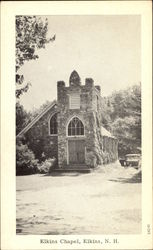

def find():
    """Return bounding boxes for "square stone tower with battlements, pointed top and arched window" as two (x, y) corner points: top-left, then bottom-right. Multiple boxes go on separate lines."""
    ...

(57, 70), (101, 168)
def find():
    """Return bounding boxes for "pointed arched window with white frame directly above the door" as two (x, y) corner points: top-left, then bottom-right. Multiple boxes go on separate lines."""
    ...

(68, 117), (84, 136)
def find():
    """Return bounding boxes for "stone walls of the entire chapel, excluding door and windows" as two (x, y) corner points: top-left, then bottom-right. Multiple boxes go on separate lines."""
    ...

(20, 72), (118, 168)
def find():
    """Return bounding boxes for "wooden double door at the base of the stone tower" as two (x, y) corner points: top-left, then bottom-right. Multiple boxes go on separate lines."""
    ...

(68, 140), (85, 164)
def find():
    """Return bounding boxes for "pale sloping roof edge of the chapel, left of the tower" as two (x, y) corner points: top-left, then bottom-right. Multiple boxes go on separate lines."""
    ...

(17, 100), (57, 137)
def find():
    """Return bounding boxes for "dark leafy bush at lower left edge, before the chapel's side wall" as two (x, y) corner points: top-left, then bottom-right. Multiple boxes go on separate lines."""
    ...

(16, 140), (38, 175)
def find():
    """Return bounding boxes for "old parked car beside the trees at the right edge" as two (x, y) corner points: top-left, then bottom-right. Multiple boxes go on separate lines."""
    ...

(119, 154), (141, 169)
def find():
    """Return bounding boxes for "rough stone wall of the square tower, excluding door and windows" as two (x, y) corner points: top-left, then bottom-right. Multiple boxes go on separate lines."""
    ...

(57, 75), (102, 167)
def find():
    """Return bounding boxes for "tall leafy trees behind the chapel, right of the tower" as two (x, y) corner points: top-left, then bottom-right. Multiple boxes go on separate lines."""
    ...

(102, 85), (141, 156)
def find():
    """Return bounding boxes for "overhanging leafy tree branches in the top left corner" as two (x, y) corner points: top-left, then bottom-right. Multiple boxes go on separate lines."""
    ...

(16, 16), (55, 98)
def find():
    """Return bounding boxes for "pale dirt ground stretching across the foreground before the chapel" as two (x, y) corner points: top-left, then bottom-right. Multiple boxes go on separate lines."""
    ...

(17, 164), (141, 234)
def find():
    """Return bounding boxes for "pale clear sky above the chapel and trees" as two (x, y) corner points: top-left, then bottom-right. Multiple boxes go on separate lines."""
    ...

(20, 15), (141, 111)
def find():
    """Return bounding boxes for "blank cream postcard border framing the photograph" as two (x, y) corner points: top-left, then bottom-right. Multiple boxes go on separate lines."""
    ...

(1, 1), (152, 250)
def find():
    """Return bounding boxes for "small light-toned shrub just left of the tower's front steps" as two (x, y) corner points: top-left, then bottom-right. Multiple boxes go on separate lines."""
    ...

(38, 158), (57, 174)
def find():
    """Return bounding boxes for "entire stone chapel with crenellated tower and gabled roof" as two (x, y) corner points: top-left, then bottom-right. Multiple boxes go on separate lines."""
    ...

(17, 71), (118, 168)
